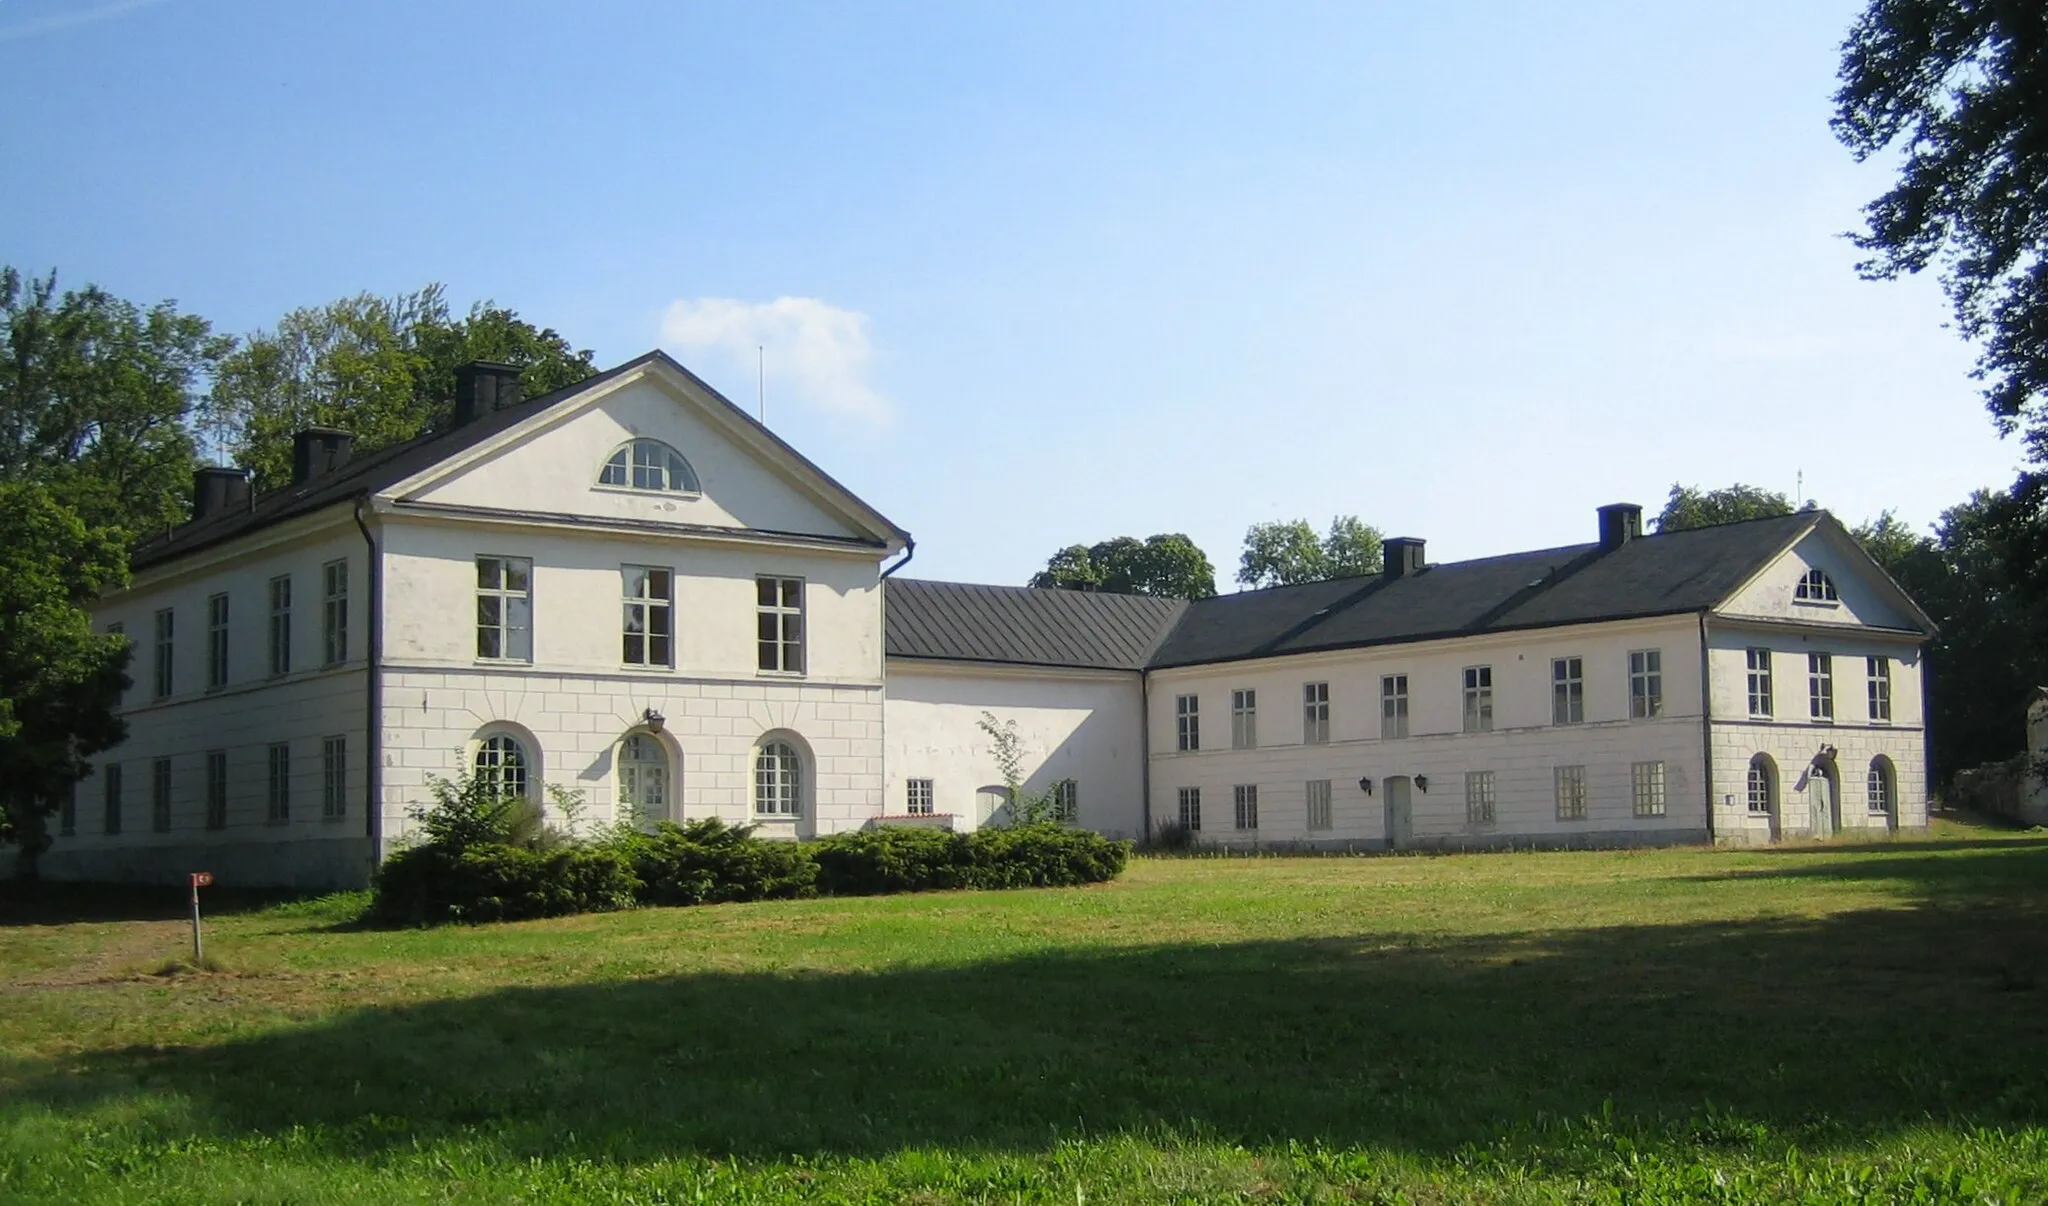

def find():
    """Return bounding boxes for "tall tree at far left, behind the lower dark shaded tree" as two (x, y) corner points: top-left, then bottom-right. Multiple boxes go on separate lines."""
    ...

(0, 268), (233, 534)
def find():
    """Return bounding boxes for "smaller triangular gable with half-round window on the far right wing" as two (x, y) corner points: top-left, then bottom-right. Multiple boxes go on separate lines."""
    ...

(1714, 512), (1935, 635)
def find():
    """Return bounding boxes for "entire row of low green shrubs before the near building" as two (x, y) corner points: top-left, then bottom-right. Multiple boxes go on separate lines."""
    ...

(371, 819), (1130, 925)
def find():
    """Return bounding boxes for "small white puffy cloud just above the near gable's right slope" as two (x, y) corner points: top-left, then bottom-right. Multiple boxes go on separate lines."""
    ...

(662, 297), (891, 422)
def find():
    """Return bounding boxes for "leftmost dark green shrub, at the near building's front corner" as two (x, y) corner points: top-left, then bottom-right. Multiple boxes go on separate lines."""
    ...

(371, 842), (639, 925)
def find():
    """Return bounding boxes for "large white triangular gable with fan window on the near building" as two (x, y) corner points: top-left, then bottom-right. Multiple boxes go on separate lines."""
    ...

(379, 352), (909, 549)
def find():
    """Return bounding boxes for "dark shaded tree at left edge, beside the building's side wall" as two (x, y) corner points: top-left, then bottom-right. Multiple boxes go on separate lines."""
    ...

(0, 483), (129, 878)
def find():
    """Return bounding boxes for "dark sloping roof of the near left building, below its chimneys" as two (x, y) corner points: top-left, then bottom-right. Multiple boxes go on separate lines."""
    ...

(129, 350), (909, 569)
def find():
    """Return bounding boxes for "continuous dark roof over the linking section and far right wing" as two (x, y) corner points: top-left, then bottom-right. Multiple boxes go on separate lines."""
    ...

(889, 512), (1900, 670)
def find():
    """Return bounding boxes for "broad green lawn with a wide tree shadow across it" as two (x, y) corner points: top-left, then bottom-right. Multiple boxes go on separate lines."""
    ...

(0, 825), (2048, 1204)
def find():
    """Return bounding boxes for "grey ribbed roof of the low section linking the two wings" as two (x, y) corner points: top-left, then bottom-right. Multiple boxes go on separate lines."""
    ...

(885, 577), (1188, 670)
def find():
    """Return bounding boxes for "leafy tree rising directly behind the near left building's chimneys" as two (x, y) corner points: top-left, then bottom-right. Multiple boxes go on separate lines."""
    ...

(209, 285), (596, 489)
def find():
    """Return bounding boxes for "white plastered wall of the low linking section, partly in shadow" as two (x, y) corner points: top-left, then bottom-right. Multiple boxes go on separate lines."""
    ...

(883, 657), (1145, 837)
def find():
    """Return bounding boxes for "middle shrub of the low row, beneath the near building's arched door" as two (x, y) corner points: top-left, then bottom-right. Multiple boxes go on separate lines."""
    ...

(616, 817), (817, 905)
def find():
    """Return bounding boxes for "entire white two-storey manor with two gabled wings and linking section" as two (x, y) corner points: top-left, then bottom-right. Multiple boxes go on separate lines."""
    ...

(43, 352), (1931, 887)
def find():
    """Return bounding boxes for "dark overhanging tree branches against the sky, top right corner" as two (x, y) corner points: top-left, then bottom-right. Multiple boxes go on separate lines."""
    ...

(1831, 0), (2048, 461)
